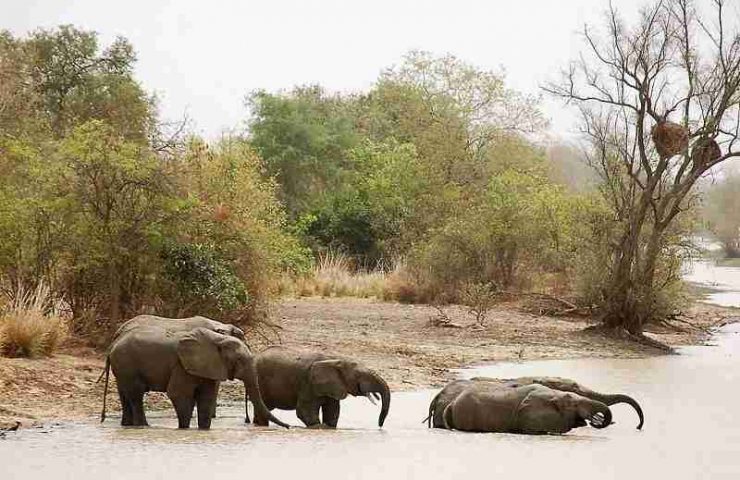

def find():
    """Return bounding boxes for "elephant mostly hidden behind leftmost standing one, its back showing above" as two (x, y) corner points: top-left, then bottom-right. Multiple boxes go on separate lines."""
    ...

(98, 315), (247, 422)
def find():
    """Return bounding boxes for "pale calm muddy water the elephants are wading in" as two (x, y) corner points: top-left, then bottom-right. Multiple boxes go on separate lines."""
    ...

(0, 262), (740, 480)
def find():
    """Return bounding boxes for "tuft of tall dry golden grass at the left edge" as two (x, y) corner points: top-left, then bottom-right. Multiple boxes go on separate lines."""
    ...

(0, 282), (68, 358)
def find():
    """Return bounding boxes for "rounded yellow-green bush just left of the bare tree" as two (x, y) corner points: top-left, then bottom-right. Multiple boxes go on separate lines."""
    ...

(409, 170), (576, 303)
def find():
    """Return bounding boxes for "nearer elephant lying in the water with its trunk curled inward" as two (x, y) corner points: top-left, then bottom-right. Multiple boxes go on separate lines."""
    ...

(442, 382), (612, 435)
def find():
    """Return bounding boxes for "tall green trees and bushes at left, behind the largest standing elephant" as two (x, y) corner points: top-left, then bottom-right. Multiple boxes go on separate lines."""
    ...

(0, 26), (311, 333)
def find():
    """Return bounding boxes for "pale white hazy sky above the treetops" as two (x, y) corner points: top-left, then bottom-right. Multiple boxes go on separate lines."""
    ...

(0, 0), (644, 136)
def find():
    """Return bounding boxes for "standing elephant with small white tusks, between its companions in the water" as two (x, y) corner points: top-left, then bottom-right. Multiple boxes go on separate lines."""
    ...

(247, 346), (391, 428)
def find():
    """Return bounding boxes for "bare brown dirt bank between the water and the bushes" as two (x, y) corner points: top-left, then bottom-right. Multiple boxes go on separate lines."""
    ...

(0, 298), (740, 427)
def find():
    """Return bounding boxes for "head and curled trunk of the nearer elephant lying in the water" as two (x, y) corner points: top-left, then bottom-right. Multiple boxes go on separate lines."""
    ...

(516, 385), (612, 433)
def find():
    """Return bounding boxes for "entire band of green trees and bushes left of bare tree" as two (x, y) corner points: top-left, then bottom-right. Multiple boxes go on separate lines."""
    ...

(5, 26), (684, 344)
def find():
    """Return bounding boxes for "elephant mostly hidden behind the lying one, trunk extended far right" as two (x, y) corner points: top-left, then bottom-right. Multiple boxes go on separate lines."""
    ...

(424, 377), (645, 430)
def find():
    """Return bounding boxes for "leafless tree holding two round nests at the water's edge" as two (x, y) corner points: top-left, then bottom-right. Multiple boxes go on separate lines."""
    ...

(545, 0), (740, 334)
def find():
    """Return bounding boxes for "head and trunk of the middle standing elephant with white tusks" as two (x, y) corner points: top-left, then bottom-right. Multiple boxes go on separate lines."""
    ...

(309, 359), (391, 427)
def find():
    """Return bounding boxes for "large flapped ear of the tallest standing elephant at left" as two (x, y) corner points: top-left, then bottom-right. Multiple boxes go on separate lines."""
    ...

(177, 328), (228, 380)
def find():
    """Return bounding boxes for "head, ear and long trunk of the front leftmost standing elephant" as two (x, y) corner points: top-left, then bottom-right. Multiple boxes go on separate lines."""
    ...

(177, 328), (290, 428)
